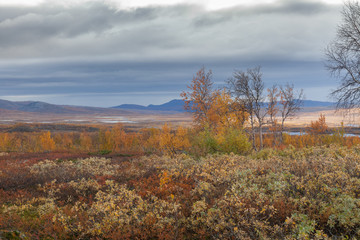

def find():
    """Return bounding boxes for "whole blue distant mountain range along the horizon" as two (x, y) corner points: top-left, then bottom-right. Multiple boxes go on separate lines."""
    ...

(0, 99), (335, 115)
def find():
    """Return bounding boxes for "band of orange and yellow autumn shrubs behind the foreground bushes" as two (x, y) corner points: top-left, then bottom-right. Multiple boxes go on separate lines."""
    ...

(0, 122), (360, 156)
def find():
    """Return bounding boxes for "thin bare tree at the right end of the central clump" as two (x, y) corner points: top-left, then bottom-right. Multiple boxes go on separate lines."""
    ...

(280, 84), (305, 141)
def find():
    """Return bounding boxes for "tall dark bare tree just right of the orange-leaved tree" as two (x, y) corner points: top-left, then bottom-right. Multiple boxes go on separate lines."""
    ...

(227, 67), (266, 149)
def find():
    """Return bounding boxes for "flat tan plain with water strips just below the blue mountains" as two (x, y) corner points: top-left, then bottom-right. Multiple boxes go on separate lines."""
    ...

(0, 108), (359, 129)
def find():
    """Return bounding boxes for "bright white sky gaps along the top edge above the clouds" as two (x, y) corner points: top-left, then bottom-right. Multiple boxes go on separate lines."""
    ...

(0, 0), (343, 11)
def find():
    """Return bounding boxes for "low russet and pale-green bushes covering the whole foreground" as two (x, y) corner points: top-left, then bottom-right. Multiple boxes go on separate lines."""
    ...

(0, 146), (360, 239)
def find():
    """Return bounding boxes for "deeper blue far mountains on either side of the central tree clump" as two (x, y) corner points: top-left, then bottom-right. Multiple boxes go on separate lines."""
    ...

(113, 99), (335, 112)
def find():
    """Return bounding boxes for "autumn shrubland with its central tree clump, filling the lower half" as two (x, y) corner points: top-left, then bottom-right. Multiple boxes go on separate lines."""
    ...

(0, 68), (360, 239)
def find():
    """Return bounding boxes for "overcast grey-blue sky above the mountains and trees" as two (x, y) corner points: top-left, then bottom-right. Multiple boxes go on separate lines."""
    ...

(0, 0), (343, 107)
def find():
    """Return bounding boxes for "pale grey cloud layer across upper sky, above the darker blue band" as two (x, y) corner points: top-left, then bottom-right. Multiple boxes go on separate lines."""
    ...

(0, 1), (342, 60)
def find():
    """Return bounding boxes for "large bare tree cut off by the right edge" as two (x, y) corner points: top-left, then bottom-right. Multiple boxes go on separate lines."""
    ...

(326, 1), (360, 109)
